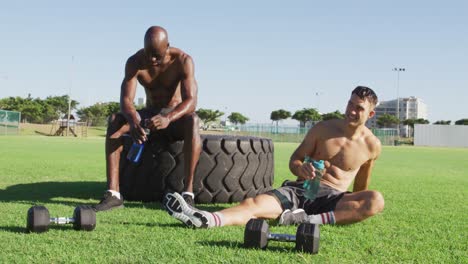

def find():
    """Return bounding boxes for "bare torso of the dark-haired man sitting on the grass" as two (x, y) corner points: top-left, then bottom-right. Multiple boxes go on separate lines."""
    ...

(312, 120), (377, 191)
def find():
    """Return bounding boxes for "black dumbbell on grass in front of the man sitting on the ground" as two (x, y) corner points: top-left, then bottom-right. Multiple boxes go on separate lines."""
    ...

(244, 219), (320, 254)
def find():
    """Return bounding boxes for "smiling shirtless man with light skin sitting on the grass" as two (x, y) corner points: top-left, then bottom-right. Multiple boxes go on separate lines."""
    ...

(164, 86), (384, 228)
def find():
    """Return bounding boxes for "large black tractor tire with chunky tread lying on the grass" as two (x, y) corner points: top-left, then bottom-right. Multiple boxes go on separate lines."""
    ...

(120, 135), (274, 203)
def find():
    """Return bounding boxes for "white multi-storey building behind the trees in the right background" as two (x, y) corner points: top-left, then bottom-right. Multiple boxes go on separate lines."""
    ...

(366, 96), (427, 136)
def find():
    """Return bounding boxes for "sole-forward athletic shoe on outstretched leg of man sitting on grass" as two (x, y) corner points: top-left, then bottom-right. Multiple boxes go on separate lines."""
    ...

(163, 193), (208, 228)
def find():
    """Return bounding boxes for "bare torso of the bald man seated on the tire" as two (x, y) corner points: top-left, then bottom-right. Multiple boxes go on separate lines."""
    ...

(130, 47), (187, 109)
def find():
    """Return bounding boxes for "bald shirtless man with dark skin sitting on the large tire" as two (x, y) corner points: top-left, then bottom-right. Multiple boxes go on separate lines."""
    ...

(94, 26), (201, 211)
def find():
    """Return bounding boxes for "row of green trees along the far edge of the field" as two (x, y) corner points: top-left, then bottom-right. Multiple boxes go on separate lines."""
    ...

(0, 95), (468, 128)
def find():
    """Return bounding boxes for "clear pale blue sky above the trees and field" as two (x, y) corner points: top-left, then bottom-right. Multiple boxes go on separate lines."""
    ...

(0, 0), (468, 123)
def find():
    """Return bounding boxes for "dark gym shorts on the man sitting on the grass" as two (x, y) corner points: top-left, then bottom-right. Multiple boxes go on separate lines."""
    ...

(266, 181), (349, 215)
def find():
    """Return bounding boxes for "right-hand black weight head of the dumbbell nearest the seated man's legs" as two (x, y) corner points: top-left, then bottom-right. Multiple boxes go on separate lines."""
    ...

(296, 223), (320, 254)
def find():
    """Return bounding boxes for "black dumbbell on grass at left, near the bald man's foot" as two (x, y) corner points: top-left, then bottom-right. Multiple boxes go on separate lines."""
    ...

(26, 205), (96, 233)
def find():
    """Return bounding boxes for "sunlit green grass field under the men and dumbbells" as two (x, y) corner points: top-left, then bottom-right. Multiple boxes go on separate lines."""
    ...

(0, 136), (468, 263)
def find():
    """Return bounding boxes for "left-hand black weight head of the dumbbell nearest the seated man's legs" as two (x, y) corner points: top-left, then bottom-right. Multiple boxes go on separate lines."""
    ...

(244, 219), (269, 249)
